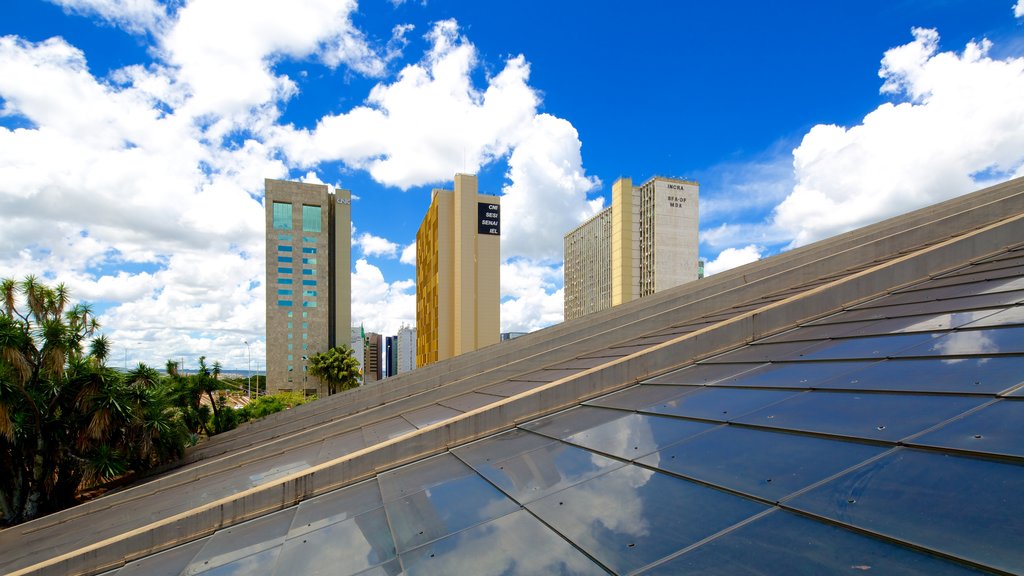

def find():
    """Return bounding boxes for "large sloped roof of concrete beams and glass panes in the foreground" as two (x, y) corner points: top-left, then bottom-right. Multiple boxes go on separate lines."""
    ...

(0, 179), (1024, 575)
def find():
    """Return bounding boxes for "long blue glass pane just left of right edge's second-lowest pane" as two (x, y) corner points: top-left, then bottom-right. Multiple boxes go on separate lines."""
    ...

(736, 392), (990, 442)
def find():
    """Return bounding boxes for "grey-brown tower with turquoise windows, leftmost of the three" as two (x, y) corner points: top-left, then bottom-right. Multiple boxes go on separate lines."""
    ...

(264, 179), (352, 397)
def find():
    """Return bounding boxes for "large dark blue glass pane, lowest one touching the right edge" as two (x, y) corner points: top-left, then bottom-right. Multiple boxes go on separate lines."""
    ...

(786, 449), (1024, 573)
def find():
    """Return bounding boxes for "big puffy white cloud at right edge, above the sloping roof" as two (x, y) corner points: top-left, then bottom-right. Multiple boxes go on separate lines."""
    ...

(772, 29), (1024, 246)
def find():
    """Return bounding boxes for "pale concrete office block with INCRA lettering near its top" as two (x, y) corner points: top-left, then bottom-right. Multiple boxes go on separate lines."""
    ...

(564, 176), (700, 320)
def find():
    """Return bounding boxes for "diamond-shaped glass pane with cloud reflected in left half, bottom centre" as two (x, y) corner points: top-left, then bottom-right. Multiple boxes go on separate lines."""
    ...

(526, 465), (766, 574)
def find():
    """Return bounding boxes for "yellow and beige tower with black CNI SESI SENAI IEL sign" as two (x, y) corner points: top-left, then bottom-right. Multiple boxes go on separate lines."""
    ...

(416, 174), (501, 366)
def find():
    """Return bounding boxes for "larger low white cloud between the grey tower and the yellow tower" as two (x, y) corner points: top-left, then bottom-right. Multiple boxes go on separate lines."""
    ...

(352, 258), (416, 336)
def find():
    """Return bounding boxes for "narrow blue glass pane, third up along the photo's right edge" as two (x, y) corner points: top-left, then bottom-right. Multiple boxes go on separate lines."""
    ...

(820, 356), (1024, 394)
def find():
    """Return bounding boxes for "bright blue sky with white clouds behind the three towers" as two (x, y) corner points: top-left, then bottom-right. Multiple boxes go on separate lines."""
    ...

(0, 0), (1024, 367)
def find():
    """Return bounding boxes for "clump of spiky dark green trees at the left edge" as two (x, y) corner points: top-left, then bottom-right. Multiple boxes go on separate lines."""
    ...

(0, 276), (184, 523)
